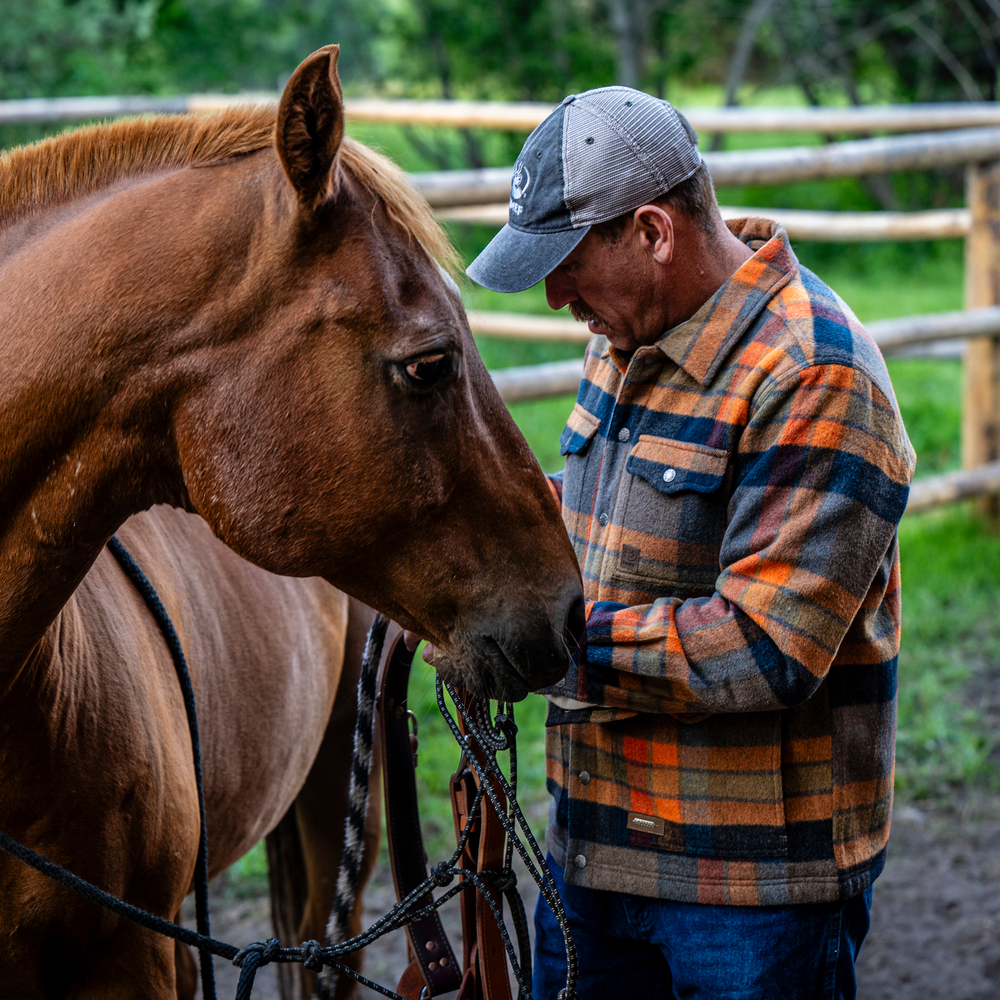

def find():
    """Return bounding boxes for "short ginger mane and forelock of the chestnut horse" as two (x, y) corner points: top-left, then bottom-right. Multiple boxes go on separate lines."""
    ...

(0, 106), (458, 271)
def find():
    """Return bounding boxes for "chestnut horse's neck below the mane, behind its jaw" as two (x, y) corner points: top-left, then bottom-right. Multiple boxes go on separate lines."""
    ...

(0, 164), (268, 676)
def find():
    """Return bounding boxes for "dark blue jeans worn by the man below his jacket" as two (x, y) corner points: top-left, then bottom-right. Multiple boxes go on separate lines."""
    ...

(531, 856), (872, 1000)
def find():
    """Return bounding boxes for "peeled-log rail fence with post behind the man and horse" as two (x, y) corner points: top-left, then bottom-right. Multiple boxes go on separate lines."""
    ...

(0, 94), (1000, 517)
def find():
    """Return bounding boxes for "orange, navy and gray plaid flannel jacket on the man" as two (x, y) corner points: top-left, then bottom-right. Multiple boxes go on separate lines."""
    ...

(546, 219), (915, 905)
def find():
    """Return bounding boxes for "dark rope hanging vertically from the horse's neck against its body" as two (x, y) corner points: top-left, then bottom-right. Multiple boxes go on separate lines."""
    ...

(108, 535), (215, 1000)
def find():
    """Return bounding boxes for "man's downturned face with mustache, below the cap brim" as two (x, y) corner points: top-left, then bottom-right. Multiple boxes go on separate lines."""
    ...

(545, 226), (667, 351)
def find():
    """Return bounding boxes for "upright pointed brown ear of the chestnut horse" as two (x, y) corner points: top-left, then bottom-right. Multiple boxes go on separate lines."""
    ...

(274, 45), (344, 209)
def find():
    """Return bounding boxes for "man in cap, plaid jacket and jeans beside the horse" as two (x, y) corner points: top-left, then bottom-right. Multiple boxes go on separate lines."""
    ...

(468, 87), (914, 1000)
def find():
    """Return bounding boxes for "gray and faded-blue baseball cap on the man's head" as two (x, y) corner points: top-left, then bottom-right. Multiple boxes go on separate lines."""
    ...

(466, 87), (701, 292)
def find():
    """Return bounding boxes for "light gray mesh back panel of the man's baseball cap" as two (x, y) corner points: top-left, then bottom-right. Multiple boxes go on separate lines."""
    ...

(563, 87), (701, 226)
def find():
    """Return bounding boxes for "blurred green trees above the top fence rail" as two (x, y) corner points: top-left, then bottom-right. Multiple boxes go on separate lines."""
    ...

(7, 0), (1000, 103)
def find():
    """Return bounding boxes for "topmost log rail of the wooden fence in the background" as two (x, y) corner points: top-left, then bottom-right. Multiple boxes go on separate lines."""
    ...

(0, 94), (1000, 135)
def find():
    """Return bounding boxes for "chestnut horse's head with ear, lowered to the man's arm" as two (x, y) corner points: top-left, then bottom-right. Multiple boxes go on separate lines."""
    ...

(161, 46), (584, 698)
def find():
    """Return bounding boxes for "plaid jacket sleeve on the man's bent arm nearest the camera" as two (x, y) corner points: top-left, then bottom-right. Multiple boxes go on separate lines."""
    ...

(576, 365), (913, 715)
